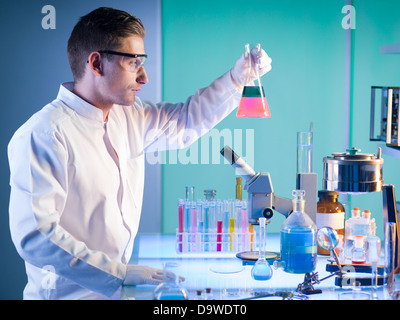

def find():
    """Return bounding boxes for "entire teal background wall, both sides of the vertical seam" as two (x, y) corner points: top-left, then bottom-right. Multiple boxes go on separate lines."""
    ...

(162, 0), (400, 237)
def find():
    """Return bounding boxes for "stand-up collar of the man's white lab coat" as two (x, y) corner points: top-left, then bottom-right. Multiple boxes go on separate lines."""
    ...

(57, 82), (104, 124)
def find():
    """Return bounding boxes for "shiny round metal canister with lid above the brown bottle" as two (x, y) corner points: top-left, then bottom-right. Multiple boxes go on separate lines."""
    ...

(322, 148), (383, 193)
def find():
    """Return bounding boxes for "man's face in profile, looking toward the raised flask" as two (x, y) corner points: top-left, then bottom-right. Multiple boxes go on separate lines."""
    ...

(101, 36), (149, 105)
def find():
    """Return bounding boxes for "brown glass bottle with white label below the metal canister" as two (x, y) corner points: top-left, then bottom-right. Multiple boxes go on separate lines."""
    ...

(317, 190), (345, 255)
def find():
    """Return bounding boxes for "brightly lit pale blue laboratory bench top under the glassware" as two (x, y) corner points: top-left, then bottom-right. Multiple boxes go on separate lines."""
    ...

(121, 234), (391, 300)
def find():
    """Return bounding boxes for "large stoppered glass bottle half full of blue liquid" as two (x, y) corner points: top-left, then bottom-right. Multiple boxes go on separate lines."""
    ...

(281, 190), (317, 273)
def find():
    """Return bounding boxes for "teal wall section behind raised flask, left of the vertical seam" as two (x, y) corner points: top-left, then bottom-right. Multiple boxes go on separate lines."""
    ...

(162, 0), (346, 233)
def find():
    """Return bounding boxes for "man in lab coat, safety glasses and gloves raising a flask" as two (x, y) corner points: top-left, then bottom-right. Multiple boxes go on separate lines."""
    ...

(8, 8), (271, 299)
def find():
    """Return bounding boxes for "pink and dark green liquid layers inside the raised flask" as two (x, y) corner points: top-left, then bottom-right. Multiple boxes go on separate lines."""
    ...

(236, 86), (271, 118)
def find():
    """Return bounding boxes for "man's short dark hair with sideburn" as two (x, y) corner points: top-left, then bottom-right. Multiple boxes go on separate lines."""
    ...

(67, 7), (146, 81)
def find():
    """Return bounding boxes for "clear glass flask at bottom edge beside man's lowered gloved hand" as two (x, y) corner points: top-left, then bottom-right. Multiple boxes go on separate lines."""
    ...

(153, 262), (189, 300)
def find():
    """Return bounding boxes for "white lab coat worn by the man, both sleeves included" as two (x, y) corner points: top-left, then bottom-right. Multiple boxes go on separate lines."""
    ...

(8, 72), (240, 299)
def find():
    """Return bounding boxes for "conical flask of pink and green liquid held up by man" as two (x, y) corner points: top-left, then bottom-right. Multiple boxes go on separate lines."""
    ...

(236, 43), (271, 118)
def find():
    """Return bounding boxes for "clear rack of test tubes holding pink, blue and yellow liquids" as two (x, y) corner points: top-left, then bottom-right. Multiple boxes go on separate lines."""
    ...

(176, 199), (256, 253)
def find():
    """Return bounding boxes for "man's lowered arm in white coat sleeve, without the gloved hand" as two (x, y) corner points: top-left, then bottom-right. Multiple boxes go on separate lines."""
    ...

(8, 128), (126, 296)
